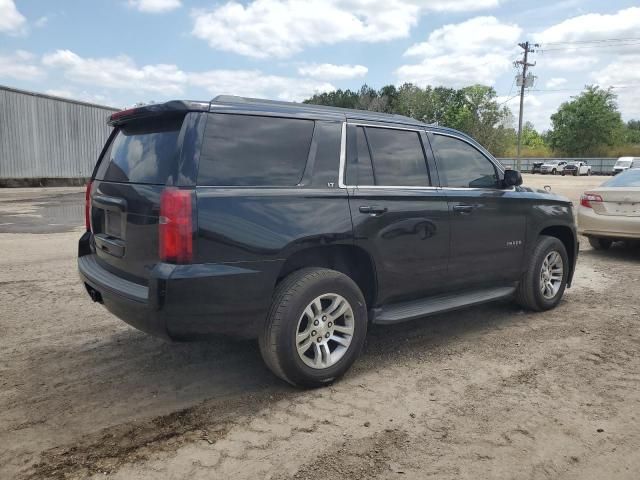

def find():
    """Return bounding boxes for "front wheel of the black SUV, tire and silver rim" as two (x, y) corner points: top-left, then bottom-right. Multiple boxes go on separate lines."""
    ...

(516, 235), (569, 312)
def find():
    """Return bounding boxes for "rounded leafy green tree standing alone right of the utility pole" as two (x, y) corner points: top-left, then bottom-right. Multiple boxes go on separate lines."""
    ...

(549, 85), (623, 157)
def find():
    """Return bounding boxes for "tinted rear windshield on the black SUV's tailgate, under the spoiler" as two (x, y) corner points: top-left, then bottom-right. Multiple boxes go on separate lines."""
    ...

(96, 114), (184, 185)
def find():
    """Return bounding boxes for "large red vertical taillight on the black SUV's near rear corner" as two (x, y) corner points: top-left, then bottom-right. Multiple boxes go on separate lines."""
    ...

(159, 188), (193, 263)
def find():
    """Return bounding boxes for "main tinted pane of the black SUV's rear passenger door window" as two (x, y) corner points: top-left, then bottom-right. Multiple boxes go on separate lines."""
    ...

(364, 127), (430, 187)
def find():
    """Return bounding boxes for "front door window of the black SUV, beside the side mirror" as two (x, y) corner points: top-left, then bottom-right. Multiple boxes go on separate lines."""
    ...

(433, 134), (498, 188)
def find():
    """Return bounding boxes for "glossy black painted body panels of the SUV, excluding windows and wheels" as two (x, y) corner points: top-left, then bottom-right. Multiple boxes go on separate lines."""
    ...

(79, 97), (578, 339)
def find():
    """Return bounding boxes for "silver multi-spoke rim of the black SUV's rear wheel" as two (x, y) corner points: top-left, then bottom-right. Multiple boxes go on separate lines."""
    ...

(296, 293), (355, 370)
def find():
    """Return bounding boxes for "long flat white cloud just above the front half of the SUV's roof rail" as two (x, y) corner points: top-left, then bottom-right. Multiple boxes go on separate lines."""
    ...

(189, 70), (335, 101)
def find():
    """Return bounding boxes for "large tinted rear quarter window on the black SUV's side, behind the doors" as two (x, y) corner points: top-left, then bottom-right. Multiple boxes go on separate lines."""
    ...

(198, 113), (314, 186)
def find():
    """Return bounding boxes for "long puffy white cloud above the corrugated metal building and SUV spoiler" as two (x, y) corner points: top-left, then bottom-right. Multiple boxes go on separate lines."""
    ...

(42, 50), (187, 95)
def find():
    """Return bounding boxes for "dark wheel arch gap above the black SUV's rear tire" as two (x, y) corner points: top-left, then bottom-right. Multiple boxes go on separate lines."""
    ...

(276, 245), (378, 306)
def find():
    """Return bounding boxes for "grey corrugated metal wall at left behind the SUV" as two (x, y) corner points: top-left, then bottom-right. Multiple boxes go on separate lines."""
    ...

(0, 86), (117, 179)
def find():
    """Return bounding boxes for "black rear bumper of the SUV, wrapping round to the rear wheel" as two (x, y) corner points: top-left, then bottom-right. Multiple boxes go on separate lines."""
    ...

(78, 232), (279, 340)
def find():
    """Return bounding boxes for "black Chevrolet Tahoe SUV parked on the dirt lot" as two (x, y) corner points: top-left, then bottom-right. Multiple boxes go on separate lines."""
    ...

(78, 97), (578, 386)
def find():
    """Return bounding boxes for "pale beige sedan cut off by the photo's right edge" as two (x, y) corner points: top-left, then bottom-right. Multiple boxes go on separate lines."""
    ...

(578, 168), (640, 250)
